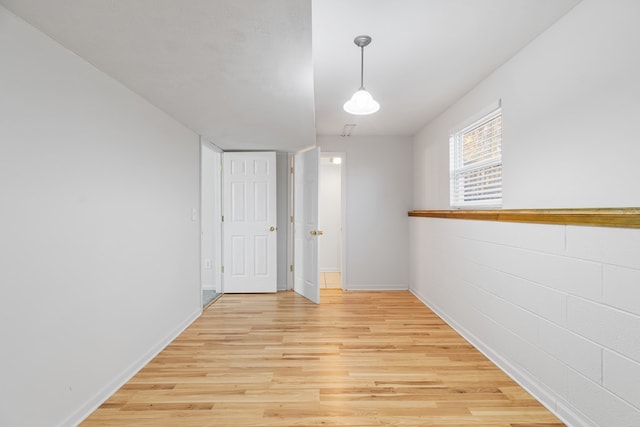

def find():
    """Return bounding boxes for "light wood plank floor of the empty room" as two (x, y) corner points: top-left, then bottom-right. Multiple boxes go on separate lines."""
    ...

(82, 289), (564, 427)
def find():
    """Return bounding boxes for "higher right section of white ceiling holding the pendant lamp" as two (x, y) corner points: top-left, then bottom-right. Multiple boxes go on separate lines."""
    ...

(312, 0), (579, 135)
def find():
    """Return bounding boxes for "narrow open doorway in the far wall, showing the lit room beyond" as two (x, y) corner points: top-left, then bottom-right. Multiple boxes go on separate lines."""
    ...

(318, 152), (346, 289)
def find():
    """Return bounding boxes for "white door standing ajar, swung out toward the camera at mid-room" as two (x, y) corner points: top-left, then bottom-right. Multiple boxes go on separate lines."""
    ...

(293, 148), (322, 304)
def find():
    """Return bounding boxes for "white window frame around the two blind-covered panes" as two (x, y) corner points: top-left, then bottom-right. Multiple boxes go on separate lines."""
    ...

(449, 102), (502, 209)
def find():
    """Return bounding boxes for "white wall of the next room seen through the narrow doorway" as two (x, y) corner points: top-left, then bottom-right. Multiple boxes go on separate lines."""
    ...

(318, 157), (342, 271)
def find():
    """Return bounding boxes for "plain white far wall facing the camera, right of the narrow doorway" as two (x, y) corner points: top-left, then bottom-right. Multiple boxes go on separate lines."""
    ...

(317, 136), (412, 289)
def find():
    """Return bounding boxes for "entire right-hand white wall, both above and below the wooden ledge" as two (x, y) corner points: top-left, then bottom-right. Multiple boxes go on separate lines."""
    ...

(411, 0), (640, 426)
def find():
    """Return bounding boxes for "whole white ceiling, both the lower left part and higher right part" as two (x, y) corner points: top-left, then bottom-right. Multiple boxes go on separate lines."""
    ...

(0, 0), (579, 151)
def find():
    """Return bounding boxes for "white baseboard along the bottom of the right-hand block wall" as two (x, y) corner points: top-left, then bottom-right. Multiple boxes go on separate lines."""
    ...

(409, 289), (597, 427)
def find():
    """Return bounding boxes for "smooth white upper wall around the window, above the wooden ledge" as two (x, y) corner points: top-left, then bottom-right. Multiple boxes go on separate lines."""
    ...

(414, 0), (640, 209)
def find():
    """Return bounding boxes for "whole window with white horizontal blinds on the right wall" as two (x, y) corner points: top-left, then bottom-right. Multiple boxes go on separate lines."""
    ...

(449, 108), (502, 208)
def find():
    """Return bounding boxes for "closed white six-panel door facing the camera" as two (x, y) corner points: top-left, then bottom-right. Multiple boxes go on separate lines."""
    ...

(222, 152), (277, 293)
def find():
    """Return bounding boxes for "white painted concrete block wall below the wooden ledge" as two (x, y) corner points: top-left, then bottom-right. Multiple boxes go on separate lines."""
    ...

(410, 218), (640, 427)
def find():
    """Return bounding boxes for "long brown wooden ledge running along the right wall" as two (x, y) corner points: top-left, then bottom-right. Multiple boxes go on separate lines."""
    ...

(409, 208), (640, 228)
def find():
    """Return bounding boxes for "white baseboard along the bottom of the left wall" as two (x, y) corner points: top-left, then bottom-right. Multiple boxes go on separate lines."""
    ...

(58, 309), (202, 427)
